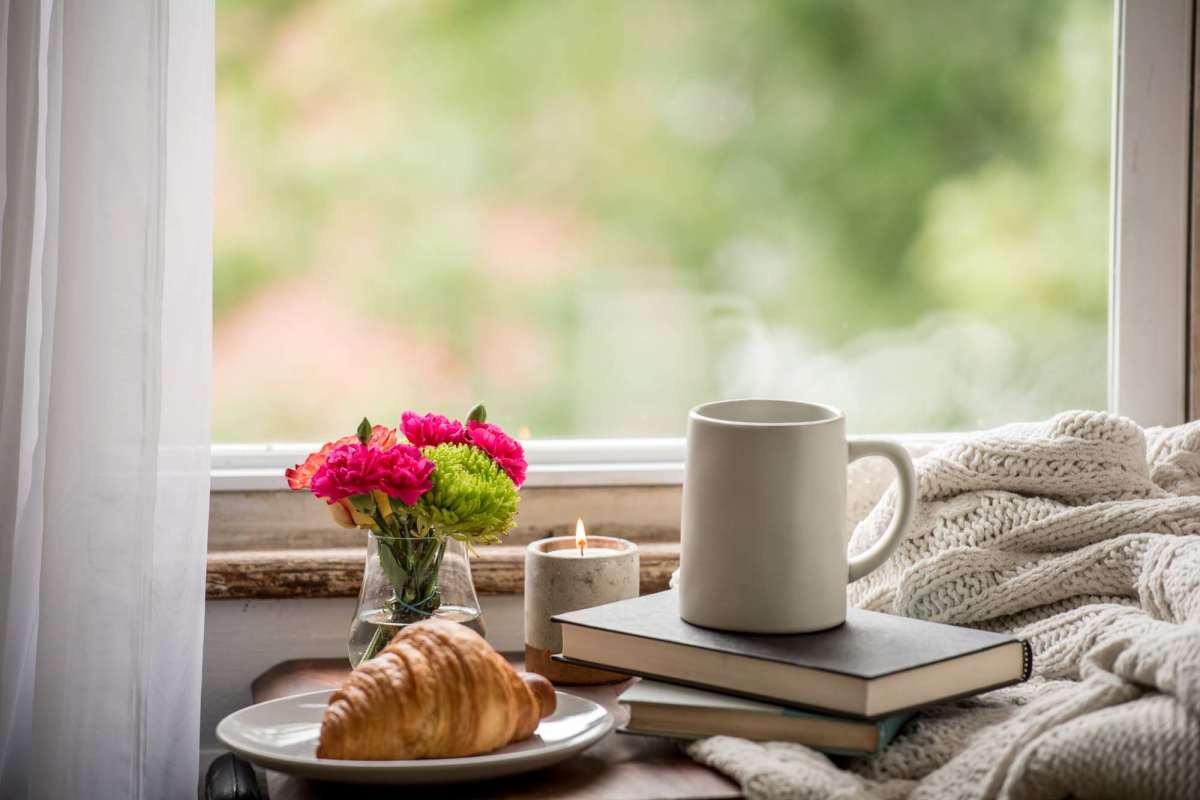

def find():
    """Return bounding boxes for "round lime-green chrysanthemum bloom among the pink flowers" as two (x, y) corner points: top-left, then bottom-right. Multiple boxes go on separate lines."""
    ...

(413, 444), (518, 545)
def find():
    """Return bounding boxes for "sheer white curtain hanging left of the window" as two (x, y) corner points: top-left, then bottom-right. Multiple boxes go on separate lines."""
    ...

(0, 0), (214, 800)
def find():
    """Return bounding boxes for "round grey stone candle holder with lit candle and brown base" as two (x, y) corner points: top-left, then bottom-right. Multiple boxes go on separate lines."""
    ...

(524, 536), (638, 685)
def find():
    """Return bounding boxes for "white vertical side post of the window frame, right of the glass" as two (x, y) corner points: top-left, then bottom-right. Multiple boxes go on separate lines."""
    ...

(1109, 0), (1195, 426)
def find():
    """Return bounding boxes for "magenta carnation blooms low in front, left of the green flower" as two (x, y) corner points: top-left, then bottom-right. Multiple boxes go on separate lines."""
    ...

(312, 443), (433, 505)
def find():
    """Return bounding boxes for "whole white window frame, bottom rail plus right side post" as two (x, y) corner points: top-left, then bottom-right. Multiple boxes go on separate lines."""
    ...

(212, 0), (1195, 492)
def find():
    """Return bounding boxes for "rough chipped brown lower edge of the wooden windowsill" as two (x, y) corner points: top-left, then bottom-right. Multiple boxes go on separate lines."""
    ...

(205, 542), (679, 600)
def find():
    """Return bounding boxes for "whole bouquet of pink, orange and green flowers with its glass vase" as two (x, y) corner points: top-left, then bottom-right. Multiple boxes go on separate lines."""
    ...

(286, 405), (526, 666)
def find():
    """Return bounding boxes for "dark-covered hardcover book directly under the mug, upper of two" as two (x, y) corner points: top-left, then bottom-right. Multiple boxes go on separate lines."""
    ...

(553, 591), (1032, 720)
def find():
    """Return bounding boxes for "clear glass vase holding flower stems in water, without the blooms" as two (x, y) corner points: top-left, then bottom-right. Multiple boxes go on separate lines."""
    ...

(348, 533), (480, 667)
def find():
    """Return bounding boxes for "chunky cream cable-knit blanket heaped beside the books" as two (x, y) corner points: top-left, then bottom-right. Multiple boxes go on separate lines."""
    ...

(688, 411), (1200, 800)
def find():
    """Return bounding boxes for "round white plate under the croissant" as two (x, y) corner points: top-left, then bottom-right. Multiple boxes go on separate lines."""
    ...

(217, 690), (613, 783)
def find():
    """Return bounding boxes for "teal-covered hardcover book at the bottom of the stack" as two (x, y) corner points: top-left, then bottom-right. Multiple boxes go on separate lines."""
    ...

(620, 680), (912, 756)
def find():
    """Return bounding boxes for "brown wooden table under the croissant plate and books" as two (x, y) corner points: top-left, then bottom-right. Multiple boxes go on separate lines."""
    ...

(252, 658), (742, 800)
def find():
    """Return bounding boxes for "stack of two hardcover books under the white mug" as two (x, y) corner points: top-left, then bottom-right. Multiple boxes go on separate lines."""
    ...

(553, 591), (1032, 754)
